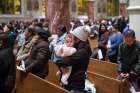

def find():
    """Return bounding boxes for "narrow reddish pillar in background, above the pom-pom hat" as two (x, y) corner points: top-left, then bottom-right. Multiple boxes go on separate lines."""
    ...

(87, 0), (95, 20)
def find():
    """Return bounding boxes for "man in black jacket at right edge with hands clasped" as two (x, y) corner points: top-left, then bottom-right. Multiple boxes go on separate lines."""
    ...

(118, 29), (140, 90)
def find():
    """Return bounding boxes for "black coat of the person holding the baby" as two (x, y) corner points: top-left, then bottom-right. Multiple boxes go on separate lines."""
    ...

(56, 41), (91, 90)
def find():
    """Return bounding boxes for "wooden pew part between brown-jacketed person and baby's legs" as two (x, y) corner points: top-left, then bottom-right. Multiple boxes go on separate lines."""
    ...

(45, 60), (60, 85)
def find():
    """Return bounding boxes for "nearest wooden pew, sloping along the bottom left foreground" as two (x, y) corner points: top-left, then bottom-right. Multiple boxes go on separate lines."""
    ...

(16, 70), (69, 93)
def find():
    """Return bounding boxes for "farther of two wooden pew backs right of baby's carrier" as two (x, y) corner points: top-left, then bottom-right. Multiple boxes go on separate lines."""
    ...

(88, 59), (118, 78)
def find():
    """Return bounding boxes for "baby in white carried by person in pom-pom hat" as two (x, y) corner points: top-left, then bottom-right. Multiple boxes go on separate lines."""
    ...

(54, 34), (76, 85)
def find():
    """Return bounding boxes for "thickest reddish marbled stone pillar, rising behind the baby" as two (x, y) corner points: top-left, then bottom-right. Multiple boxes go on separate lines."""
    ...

(46, 0), (70, 33)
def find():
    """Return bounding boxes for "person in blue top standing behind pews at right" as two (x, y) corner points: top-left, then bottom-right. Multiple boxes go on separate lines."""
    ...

(106, 24), (123, 63)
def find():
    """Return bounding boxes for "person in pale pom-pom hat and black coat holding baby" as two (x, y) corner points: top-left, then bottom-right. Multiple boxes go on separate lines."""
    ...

(56, 26), (91, 93)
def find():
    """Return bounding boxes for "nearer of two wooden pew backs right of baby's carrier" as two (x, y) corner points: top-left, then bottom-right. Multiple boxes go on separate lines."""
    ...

(87, 71), (121, 93)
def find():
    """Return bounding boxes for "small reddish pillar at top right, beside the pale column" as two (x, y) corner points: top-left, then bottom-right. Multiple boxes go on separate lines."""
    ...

(119, 0), (127, 16)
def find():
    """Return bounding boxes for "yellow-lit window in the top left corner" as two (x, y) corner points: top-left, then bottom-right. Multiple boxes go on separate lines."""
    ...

(0, 0), (21, 15)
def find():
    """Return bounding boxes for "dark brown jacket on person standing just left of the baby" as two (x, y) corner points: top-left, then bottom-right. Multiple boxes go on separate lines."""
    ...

(25, 40), (50, 78)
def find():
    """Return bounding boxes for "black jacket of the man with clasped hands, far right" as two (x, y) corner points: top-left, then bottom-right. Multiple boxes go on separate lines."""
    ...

(118, 41), (140, 87)
